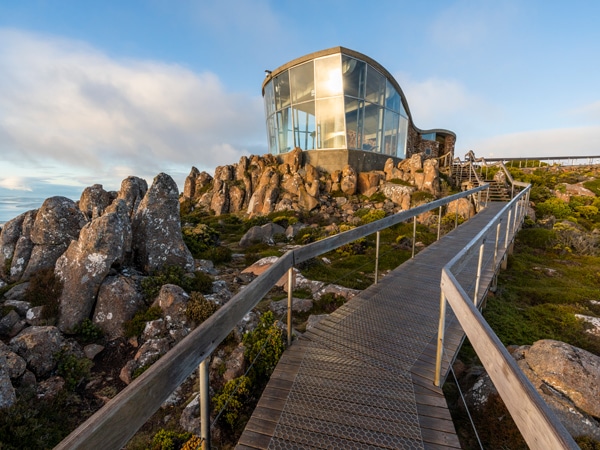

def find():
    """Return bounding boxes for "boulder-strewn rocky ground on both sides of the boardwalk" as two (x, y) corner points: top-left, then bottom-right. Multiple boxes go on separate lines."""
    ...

(0, 151), (600, 448)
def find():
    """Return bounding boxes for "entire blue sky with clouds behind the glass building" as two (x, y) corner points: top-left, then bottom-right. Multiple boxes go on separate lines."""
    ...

(0, 0), (600, 197)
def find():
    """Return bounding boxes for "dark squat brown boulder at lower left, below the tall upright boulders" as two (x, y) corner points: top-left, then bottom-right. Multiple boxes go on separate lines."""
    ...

(9, 326), (65, 379)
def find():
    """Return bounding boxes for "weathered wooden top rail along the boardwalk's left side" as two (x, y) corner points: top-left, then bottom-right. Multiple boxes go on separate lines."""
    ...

(55, 184), (488, 450)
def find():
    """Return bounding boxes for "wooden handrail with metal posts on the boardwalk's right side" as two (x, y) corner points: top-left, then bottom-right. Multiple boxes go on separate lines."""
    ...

(435, 185), (579, 450)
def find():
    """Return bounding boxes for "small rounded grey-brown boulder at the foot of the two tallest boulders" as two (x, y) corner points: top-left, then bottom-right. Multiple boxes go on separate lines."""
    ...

(92, 274), (145, 340)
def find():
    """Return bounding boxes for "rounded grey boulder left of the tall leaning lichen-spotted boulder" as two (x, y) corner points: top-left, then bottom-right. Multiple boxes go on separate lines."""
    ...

(22, 197), (87, 279)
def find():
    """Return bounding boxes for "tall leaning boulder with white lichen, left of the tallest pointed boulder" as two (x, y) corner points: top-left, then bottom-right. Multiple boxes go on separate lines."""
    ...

(55, 200), (131, 332)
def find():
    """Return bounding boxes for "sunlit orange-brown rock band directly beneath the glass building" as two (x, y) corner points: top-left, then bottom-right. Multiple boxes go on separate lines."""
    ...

(181, 148), (440, 216)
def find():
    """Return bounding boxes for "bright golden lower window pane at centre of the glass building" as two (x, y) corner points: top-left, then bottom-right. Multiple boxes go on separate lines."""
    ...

(317, 97), (346, 148)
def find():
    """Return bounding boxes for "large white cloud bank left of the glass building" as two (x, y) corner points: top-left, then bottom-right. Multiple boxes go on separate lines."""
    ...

(0, 29), (266, 190)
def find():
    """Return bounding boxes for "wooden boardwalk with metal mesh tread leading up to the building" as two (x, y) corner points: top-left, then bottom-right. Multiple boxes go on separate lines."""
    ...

(236, 203), (505, 449)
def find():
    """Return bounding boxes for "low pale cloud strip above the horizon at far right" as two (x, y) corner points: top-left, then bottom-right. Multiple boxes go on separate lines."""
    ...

(468, 125), (600, 157)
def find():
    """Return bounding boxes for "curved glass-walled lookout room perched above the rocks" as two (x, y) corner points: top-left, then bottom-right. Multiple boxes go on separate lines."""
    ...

(263, 47), (453, 165)
